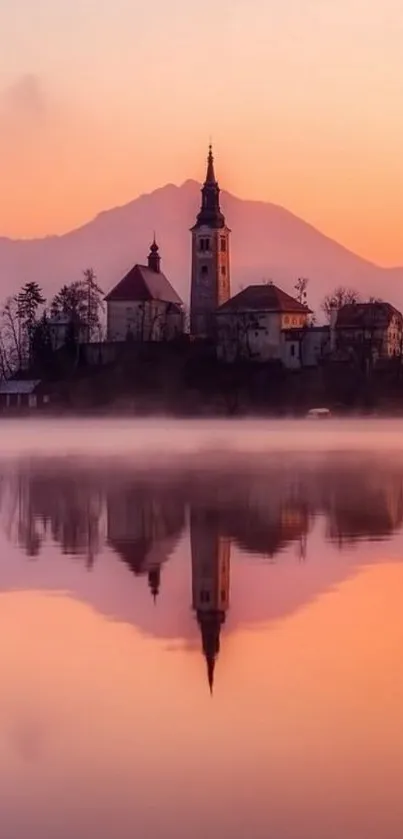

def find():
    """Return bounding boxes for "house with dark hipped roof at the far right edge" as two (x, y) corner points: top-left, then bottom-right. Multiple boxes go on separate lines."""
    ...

(335, 301), (403, 361)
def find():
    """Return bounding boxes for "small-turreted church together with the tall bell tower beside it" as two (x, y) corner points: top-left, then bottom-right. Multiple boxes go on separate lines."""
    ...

(105, 146), (230, 342)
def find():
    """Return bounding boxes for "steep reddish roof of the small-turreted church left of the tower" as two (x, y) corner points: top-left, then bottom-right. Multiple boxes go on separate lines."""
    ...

(105, 265), (182, 306)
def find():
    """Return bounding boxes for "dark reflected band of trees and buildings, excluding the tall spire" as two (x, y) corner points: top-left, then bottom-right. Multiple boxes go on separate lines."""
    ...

(0, 455), (403, 572)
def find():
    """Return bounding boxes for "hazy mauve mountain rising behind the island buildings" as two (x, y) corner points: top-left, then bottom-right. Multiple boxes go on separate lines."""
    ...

(0, 181), (403, 316)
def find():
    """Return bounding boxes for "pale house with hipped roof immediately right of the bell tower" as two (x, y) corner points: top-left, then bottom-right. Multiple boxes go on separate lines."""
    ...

(216, 283), (311, 367)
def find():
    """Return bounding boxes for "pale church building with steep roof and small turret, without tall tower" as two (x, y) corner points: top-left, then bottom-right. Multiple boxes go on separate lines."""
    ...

(105, 239), (184, 341)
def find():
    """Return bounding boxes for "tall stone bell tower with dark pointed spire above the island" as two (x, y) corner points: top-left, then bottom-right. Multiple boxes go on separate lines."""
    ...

(190, 146), (231, 338)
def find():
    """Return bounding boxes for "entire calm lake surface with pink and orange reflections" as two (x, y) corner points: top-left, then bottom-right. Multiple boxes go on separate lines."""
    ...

(0, 421), (403, 839)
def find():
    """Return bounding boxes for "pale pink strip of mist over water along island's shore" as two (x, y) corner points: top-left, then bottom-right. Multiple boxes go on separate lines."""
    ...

(0, 418), (403, 465)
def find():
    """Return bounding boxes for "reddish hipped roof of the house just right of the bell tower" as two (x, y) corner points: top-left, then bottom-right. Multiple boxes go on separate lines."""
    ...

(218, 283), (311, 314)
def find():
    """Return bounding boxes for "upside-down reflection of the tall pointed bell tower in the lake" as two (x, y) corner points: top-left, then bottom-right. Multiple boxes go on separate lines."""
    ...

(190, 510), (231, 692)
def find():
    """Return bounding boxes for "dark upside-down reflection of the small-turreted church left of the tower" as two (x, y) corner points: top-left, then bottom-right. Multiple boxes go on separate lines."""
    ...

(107, 484), (183, 600)
